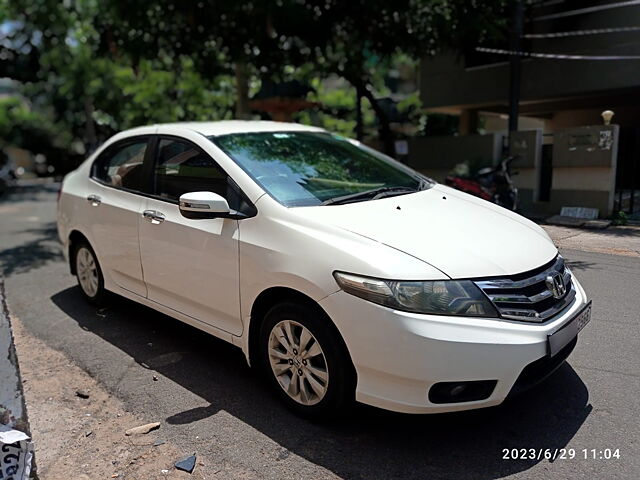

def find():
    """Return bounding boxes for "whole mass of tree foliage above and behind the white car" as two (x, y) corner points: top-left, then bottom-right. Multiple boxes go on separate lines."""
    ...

(0, 0), (509, 166)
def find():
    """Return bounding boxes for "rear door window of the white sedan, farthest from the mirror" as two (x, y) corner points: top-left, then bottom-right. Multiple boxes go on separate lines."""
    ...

(93, 138), (147, 190)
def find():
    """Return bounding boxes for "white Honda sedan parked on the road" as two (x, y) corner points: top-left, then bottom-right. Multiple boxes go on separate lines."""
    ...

(58, 121), (591, 417)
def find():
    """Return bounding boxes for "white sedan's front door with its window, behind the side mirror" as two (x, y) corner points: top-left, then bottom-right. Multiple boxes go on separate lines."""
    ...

(139, 137), (242, 335)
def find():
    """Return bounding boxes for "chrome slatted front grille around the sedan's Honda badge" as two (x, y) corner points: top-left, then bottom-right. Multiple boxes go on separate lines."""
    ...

(475, 255), (576, 323)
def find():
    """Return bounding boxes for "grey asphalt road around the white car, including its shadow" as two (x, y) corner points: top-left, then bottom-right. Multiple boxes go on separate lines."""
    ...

(0, 185), (640, 480)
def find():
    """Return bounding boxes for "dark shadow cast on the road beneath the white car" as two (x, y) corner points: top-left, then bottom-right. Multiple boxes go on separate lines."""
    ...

(51, 287), (592, 480)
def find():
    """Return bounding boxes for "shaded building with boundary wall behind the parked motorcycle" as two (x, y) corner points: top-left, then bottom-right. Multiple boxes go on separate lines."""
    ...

(420, 0), (640, 216)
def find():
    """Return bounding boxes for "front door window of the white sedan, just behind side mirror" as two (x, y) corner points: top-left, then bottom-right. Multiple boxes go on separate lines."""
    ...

(154, 139), (228, 201)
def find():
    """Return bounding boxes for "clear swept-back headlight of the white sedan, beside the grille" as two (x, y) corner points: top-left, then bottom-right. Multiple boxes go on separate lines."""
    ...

(333, 272), (498, 318)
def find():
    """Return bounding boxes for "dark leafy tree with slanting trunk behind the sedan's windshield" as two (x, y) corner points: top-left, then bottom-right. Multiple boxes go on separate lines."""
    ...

(262, 0), (507, 153)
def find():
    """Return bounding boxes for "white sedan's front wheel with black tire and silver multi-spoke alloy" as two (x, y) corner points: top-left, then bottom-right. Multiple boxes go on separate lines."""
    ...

(260, 303), (355, 419)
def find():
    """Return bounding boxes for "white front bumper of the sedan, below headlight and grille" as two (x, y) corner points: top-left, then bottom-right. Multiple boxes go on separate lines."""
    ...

(320, 277), (587, 413)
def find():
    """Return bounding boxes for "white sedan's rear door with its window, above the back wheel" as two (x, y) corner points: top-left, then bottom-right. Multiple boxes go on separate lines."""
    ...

(85, 136), (150, 297)
